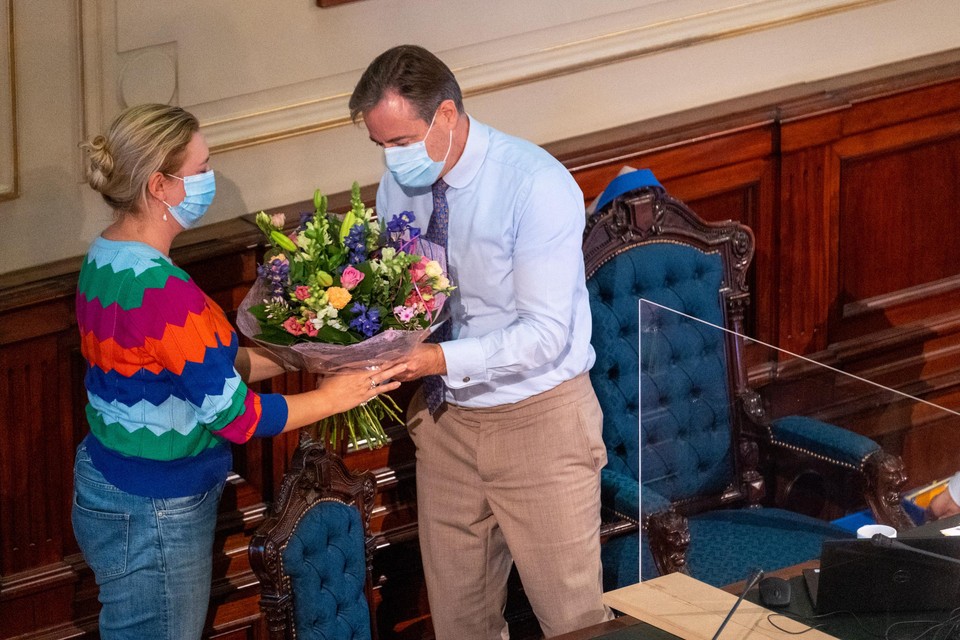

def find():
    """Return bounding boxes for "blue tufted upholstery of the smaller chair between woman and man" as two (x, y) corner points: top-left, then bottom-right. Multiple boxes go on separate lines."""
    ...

(283, 500), (370, 640)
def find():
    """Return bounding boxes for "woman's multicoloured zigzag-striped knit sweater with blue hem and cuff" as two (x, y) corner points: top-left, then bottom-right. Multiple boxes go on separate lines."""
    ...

(77, 238), (287, 498)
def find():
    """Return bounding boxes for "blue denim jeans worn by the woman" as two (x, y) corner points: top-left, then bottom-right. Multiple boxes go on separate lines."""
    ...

(73, 444), (223, 640)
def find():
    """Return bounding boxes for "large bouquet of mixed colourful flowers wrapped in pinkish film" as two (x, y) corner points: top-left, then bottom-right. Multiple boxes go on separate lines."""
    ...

(237, 183), (454, 448)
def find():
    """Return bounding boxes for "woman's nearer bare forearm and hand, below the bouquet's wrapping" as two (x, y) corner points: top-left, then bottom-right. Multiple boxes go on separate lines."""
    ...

(283, 364), (406, 431)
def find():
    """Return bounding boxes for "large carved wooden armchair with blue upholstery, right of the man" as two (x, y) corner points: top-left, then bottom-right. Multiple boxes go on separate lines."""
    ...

(584, 179), (913, 589)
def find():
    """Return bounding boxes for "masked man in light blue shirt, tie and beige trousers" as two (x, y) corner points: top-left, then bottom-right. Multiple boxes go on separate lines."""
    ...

(350, 45), (610, 640)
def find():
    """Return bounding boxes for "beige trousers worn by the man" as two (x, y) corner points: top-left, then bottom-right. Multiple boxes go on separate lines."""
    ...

(408, 374), (611, 640)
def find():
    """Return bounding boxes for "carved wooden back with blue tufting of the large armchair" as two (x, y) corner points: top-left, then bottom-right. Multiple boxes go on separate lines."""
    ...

(584, 187), (763, 513)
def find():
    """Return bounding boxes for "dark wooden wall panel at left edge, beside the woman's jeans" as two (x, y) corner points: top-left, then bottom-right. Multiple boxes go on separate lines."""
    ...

(0, 333), (75, 637)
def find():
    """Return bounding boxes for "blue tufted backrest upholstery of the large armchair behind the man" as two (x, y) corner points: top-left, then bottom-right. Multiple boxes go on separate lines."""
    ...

(587, 243), (733, 501)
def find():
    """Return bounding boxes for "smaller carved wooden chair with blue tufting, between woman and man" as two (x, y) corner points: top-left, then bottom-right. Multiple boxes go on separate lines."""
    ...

(249, 433), (377, 640)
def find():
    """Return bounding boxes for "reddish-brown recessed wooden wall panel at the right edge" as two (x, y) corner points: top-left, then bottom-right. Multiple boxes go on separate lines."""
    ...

(833, 122), (960, 339)
